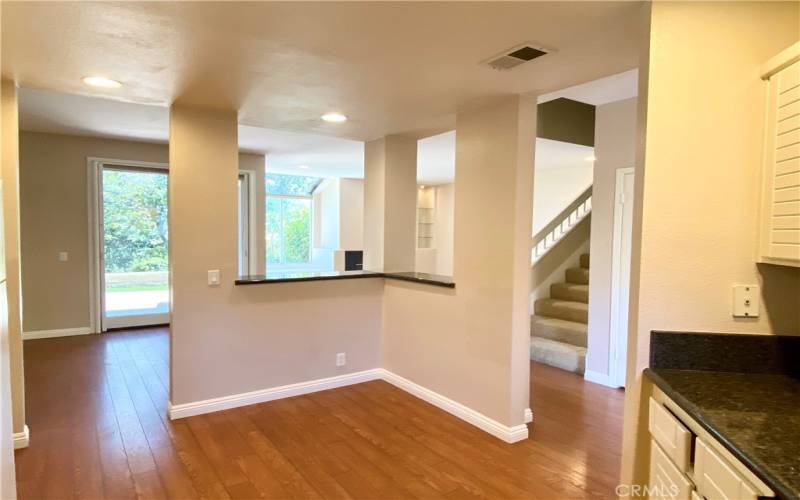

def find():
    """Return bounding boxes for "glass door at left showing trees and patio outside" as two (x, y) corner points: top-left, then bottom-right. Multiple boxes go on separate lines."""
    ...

(99, 165), (169, 330)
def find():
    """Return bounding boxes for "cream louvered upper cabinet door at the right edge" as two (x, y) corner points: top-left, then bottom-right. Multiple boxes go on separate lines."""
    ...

(759, 61), (800, 266)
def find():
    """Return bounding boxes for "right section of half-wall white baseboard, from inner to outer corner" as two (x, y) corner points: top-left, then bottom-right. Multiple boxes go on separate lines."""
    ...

(381, 369), (528, 443)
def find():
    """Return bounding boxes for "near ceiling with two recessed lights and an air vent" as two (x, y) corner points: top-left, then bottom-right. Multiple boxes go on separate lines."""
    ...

(2, 1), (644, 140)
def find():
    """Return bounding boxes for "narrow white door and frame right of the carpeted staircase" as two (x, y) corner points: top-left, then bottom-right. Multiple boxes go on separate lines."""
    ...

(608, 167), (634, 387)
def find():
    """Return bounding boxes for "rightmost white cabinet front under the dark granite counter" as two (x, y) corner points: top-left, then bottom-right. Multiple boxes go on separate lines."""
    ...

(694, 439), (758, 500)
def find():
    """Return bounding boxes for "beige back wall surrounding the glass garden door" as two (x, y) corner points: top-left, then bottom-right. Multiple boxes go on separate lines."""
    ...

(20, 131), (265, 332)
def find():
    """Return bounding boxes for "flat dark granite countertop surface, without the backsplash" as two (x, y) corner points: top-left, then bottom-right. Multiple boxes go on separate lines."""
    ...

(645, 368), (800, 500)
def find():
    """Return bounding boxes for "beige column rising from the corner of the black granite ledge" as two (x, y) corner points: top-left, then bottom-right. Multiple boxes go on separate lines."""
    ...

(364, 135), (417, 271)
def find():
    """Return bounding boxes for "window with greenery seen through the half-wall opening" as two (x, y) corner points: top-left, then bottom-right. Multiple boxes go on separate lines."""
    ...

(266, 174), (322, 267)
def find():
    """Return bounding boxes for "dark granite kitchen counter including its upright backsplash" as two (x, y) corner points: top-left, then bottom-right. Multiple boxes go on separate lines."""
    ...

(645, 332), (800, 500)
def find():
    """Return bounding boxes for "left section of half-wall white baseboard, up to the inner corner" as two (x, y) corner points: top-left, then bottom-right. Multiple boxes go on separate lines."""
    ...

(169, 368), (381, 420)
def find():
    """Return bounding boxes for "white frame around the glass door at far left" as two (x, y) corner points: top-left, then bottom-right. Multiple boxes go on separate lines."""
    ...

(86, 156), (169, 333)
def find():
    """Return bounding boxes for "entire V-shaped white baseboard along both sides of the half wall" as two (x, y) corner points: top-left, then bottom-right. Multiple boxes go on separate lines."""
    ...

(168, 368), (533, 443)
